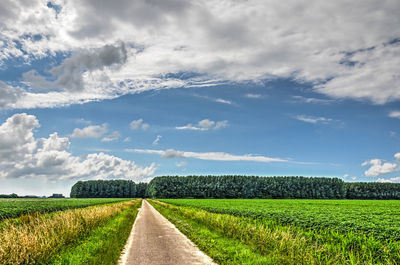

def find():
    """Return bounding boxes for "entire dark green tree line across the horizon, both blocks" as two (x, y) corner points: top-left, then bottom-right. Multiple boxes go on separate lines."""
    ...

(71, 175), (400, 199)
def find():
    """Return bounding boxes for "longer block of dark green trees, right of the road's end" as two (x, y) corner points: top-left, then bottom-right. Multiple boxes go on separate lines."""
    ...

(147, 176), (400, 199)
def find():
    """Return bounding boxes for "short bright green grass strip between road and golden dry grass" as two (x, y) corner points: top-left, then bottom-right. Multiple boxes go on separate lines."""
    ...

(49, 200), (141, 265)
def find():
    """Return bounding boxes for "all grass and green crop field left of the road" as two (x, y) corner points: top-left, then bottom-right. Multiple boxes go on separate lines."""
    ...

(0, 199), (141, 264)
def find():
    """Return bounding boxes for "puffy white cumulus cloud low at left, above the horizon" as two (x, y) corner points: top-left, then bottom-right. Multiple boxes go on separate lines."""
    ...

(0, 113), (156, 180)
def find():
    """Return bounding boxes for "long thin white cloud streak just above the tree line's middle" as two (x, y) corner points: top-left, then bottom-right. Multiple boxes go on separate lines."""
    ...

(125, 149), (289, 163)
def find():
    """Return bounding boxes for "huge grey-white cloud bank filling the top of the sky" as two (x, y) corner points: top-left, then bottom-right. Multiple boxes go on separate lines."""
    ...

(0, 0), (400, 108)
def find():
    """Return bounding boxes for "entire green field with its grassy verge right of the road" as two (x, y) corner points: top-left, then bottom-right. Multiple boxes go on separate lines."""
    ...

(151, 199), (400, 264)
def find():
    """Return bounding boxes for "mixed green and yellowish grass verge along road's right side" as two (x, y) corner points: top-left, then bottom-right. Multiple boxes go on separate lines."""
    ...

(151, 201), (400, 264)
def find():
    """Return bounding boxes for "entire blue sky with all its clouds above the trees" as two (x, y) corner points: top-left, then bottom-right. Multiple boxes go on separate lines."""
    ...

(0, 0), (400, 195)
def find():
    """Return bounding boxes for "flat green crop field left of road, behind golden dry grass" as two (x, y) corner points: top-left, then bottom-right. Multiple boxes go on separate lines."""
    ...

(0, 199), (129, 220)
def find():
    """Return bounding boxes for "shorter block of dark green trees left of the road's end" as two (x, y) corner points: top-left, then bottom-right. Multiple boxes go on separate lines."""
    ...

(71, 180), (136, 198)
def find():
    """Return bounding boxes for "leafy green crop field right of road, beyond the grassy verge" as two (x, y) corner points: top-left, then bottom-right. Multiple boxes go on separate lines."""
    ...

(161, 199), (400, 240)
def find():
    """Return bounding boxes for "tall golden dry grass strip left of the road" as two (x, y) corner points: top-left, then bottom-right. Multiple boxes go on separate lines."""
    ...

(0, 201), (134, 264)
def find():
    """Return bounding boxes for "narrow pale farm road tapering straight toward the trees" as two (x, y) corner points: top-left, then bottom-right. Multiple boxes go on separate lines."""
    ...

(120, 200), (215, 265)
